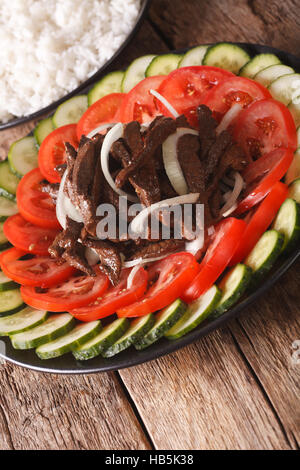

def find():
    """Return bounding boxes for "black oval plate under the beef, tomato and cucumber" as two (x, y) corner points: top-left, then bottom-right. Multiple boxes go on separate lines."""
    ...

(0, 43), (300, 374)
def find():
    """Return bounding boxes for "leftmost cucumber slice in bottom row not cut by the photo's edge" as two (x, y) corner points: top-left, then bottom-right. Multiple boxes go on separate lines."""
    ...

(10, 313), (75, 349)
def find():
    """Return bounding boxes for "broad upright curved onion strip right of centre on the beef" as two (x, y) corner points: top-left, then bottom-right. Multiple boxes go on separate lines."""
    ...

(162, 127), (198, 195)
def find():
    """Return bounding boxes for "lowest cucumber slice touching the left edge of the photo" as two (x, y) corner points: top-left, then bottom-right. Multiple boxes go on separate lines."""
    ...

(0, 306), (48, 336)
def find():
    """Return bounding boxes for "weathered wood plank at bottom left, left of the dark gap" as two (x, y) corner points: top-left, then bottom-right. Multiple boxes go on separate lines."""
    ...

(0, 363), (151, 450)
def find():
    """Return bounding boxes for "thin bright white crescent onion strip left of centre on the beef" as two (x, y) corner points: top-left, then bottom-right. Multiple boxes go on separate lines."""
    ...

(101, 122), (138, 202)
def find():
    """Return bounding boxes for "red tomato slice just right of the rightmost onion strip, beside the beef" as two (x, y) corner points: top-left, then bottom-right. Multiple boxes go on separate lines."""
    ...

(235, 148), (294, 214)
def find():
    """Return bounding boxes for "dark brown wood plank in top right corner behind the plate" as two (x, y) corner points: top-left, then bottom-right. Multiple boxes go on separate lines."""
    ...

(150, 0), (300, 55)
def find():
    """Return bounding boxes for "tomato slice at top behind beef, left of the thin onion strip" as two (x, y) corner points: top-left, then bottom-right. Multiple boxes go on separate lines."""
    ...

(120, 75), (166, 123)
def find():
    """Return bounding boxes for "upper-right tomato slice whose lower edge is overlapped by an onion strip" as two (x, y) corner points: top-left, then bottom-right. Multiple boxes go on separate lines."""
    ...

(201, 77), (272, 121)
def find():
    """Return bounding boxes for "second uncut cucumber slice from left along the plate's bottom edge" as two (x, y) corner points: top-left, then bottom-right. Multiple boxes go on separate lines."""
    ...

(35, 320), (102, 359)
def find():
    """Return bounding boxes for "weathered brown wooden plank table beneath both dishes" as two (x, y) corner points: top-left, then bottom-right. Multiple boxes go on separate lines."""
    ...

(0, 0), (300, 450)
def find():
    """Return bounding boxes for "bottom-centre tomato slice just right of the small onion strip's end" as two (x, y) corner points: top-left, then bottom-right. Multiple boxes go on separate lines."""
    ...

(117, 252), (199, 317)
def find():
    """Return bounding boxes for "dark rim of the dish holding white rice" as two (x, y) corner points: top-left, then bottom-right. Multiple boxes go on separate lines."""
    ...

(0, 0), (151, 131)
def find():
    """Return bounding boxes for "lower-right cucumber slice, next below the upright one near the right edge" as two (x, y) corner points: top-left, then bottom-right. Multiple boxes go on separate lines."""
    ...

(245, 230), (284, 281)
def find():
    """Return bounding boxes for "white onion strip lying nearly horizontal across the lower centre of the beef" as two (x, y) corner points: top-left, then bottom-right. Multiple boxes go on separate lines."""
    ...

(129, 193), (199, 234)
